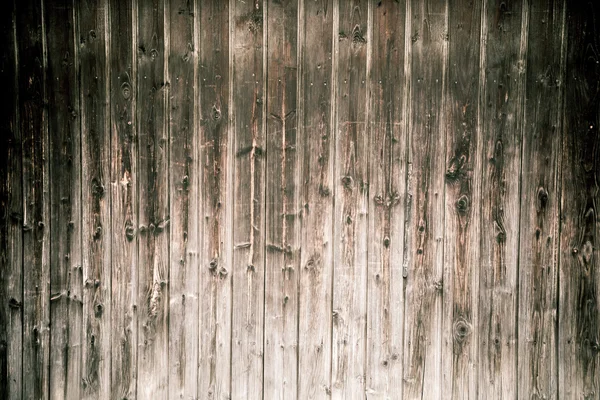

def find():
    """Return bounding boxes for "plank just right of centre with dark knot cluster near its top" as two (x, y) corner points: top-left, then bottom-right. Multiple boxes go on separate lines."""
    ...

(331, 0), (371, 399)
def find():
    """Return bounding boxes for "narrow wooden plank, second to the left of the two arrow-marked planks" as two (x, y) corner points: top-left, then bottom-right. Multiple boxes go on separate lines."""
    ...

(166, 0), (199, 399)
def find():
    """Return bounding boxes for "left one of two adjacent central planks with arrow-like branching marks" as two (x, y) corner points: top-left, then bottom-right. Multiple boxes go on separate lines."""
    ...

(229, 0), (266, 398)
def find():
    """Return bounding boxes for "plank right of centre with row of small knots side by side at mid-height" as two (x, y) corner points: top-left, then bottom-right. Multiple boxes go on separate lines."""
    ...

(364, 1), (409, 398)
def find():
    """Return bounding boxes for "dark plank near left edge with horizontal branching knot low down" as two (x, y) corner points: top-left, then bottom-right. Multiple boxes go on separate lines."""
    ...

(44, 0), (83, 399)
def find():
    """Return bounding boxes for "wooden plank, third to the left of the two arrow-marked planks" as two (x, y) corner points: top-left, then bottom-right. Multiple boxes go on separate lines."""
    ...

(136, 0), (171, 399)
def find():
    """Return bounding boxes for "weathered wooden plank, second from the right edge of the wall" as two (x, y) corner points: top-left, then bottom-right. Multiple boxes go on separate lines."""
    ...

(517, 0), (568, 399)
